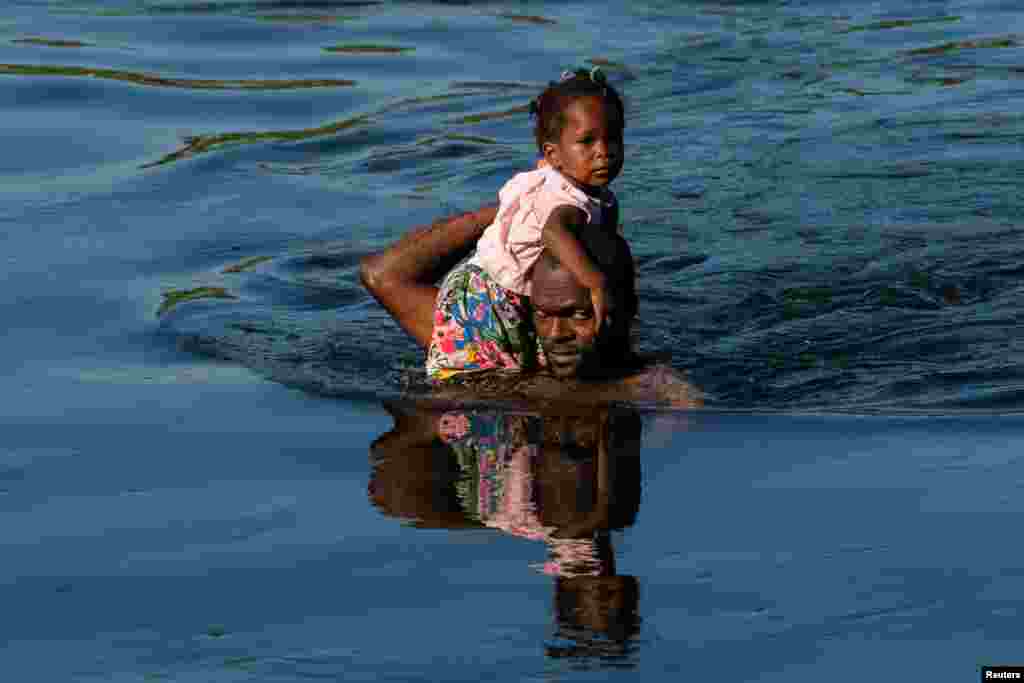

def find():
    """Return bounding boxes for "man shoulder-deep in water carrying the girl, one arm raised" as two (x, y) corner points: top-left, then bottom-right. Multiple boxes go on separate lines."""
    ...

(359, 206), (701, 408)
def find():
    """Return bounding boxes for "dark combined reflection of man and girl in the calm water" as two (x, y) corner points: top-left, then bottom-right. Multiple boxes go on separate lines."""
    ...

(369, 402), (642, 661)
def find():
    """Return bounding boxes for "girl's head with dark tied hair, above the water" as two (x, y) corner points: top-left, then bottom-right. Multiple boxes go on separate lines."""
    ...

(530, 68), (626, 188)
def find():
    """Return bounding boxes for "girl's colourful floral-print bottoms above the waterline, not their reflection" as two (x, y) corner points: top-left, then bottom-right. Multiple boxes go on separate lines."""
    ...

(427, 260), (543, 380)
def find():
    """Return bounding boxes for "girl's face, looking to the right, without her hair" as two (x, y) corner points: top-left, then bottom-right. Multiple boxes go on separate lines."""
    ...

(544, 95), (623, 191)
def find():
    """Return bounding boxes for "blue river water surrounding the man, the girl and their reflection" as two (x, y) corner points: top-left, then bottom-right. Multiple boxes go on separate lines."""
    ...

(0, 0), (1024, 681)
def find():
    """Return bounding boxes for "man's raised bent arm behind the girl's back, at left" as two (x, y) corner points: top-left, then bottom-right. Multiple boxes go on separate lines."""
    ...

(359, 205), (498, 348)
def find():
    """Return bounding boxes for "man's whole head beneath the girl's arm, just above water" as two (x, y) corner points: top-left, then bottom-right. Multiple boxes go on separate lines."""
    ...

(530, 230), (637, 378)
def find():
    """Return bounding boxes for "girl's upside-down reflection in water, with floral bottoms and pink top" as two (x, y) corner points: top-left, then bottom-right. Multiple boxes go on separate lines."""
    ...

(438, 405), (639, 659)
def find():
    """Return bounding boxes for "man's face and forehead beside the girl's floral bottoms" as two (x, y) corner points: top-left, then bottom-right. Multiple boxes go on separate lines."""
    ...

(530, 267), (597, 378)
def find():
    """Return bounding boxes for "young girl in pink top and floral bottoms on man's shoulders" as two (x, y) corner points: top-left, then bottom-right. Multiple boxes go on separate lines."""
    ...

(427, 69), (626, 380)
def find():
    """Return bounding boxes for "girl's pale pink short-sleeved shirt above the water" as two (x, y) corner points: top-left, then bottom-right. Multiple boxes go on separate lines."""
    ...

(472, 166), (615, 296)
